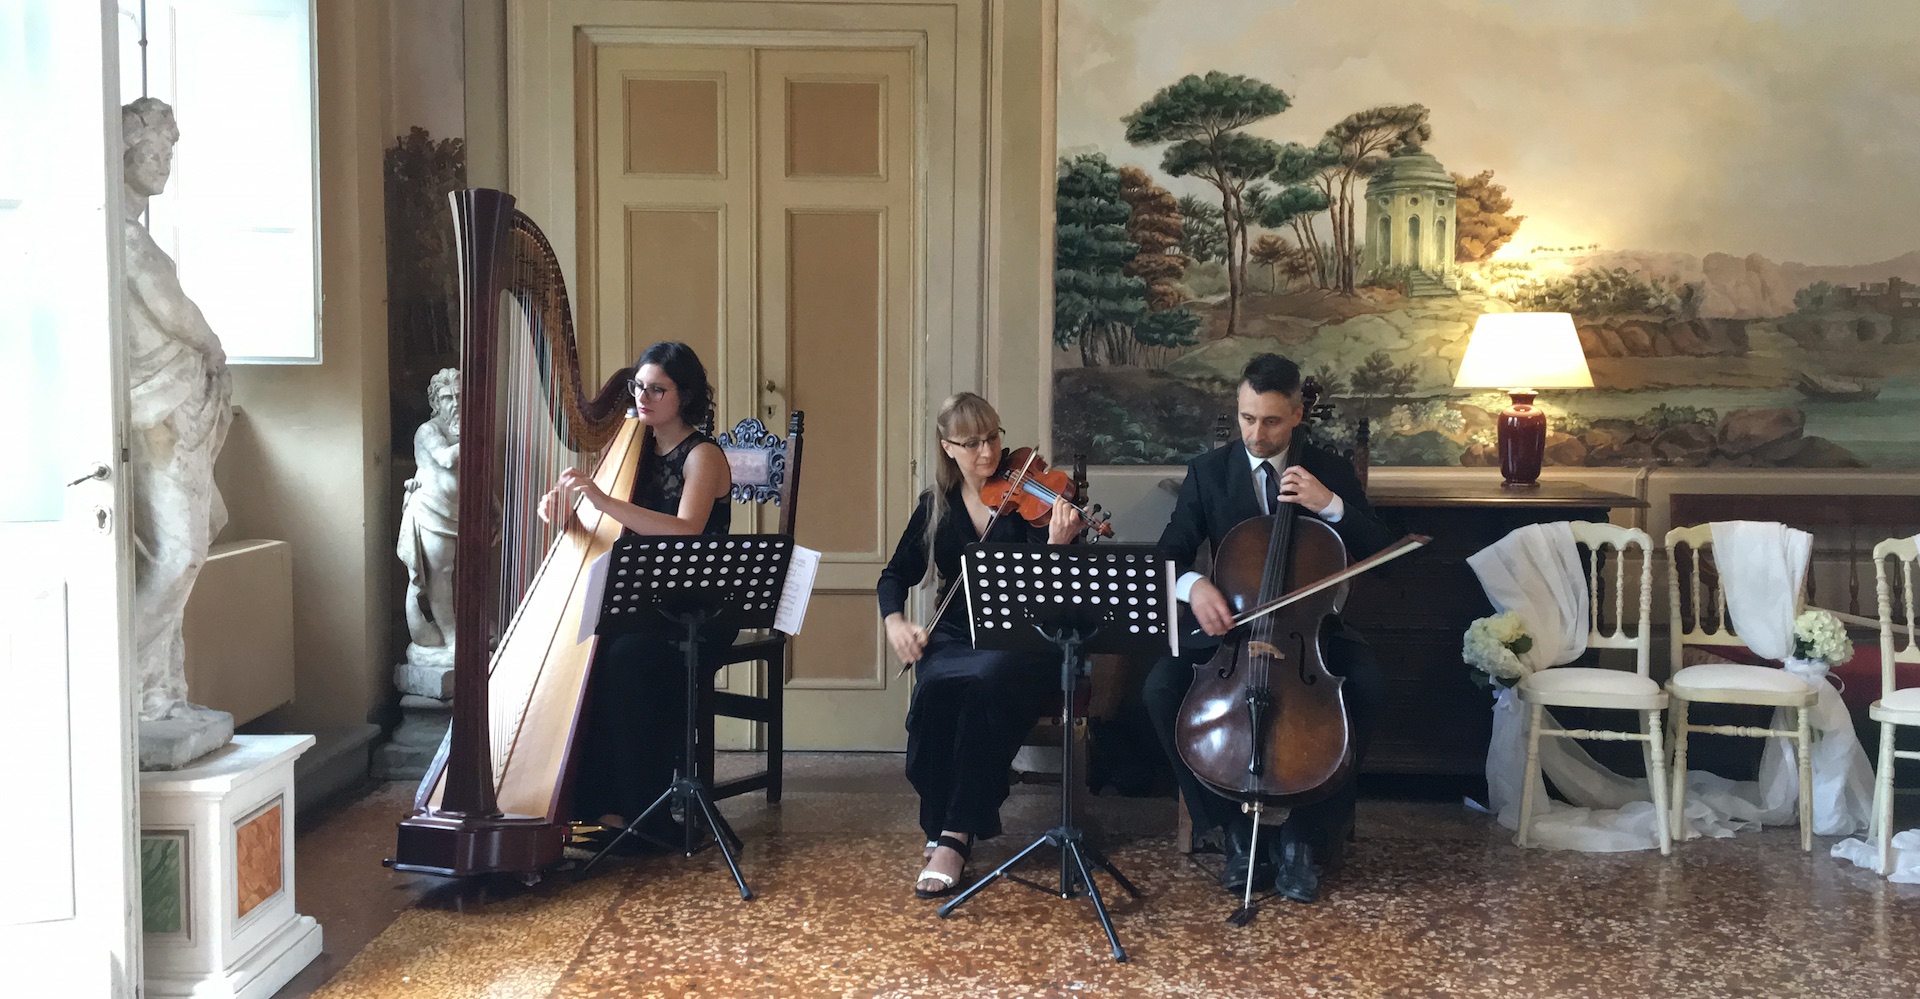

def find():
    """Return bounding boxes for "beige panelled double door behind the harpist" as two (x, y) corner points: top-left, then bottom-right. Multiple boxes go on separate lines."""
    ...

(582, 44), (924, 749)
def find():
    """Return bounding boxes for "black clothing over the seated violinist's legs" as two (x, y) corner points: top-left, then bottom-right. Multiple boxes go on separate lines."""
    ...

(906, 636), (1060, 840)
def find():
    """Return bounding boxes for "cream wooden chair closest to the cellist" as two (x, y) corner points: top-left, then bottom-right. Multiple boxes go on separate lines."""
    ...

(1515, 521), (1672, 853)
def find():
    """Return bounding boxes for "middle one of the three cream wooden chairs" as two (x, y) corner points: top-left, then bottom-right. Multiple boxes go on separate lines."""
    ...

(1667, 524), (1818, 851)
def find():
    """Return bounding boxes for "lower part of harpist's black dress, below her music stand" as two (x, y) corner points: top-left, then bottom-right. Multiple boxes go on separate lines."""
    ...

(574, 621), (739, 830)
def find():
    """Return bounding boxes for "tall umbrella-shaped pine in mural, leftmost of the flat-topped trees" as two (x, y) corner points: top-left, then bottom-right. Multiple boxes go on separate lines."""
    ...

(1121, 71), (1292, 336)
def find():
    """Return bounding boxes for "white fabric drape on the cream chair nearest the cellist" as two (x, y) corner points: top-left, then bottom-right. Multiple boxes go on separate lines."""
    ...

(1467, 523), (1661, 853)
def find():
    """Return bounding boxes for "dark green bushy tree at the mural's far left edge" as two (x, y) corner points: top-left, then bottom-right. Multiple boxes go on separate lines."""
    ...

(1054, 154), (1146, 367)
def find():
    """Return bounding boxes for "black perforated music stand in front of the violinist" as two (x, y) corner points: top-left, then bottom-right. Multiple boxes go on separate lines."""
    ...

(939, 544), (1179, 961)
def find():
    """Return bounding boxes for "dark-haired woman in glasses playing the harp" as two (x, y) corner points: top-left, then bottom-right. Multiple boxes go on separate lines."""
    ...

(540, 342), (737, 841)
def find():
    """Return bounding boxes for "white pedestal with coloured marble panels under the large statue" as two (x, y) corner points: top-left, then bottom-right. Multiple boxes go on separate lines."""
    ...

(140, 736), (321, 999)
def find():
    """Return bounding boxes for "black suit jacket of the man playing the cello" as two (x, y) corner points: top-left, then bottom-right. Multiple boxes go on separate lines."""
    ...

(1160, 440), (1394, 653)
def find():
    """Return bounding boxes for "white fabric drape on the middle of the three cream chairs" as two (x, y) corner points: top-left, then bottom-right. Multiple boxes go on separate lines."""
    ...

(1674, 521), (1874, 836)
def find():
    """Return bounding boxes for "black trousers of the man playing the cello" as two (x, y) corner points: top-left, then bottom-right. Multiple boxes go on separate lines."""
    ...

(1142, 632), (1386, 847)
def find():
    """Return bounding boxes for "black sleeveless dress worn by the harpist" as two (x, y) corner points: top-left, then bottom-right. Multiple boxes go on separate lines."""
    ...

(574, 430), (737, 826)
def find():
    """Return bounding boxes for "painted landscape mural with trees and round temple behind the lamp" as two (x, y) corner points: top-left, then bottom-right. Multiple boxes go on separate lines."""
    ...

(1054, 0), (1920, 469)
